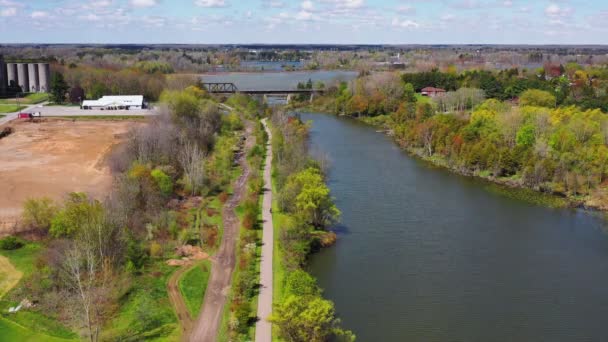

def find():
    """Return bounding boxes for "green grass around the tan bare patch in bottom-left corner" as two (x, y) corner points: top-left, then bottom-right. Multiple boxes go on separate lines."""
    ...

(0, 243), (77, 341)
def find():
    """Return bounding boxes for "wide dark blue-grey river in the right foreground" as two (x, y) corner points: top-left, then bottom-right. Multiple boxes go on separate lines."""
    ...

(302, 114), (608, 341)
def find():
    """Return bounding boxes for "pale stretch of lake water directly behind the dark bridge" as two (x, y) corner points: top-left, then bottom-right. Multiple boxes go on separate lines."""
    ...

(201, 70), (358, 90)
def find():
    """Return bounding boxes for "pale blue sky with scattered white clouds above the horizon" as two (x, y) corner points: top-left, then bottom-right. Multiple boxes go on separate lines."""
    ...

(0, 0), (608, 44)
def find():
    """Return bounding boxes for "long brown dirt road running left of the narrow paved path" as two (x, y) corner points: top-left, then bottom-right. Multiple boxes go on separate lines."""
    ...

(190, 122), (255, 342)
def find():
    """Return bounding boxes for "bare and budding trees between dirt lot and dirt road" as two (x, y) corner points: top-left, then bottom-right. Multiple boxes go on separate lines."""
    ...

(7, 86), (251, 341)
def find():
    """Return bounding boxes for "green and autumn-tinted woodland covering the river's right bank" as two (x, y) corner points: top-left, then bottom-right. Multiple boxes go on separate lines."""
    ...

(288, 63), (608, 211)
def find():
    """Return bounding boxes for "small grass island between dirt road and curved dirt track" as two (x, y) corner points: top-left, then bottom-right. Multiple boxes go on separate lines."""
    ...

(179, 260), (211, 317)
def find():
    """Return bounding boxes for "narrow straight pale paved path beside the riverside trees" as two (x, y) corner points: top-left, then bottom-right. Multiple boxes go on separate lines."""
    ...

(255, 119), (274, 342)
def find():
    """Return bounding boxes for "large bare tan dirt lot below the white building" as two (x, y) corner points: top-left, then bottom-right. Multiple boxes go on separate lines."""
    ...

(0, 119), (136, 234)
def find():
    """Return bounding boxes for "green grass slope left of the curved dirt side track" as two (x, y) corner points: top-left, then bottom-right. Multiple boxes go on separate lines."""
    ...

(101, 260), (181, 341)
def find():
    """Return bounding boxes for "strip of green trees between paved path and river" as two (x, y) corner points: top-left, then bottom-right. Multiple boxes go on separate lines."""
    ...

(269, 109), (355, 342)
